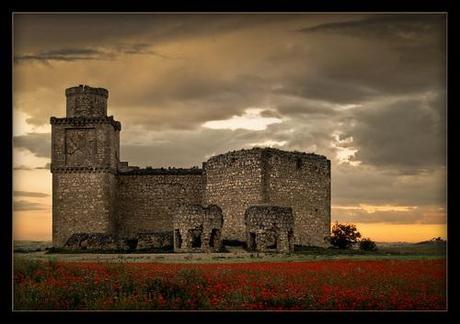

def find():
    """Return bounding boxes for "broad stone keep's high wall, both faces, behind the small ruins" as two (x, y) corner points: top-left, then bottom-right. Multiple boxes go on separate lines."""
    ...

(204, 148), (331, 246)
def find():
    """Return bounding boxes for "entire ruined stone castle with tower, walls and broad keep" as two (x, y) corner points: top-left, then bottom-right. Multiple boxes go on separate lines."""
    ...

(50, 85), (331, 252)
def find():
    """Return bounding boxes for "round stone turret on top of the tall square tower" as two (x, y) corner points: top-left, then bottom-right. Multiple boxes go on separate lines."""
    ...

(65, 85), (109, 118)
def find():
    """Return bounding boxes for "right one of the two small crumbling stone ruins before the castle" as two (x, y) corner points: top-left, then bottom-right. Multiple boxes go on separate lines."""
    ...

(244, 205), (294, 253)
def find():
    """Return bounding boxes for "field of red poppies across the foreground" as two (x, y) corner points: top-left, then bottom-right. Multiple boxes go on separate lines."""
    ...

(14, 259), (447, 310)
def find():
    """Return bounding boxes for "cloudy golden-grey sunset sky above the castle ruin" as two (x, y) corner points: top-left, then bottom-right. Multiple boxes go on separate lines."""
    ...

(13, 14), (447, 242)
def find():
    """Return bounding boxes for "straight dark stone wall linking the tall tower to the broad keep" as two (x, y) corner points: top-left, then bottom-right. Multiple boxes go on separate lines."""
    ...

(116, 169), (203, 237)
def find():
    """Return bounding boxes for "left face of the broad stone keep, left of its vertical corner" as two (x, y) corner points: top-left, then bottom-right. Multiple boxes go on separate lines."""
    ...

(203, 149), (262, 241)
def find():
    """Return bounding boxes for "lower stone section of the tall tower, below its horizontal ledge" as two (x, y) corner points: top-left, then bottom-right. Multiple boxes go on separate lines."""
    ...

(53, 171), (116, 247)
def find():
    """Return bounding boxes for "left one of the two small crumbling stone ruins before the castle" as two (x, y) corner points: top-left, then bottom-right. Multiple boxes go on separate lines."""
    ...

(174, 204), (223, 252)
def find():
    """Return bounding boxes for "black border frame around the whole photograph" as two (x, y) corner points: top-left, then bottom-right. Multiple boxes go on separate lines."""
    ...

(0, 0), (459, 323)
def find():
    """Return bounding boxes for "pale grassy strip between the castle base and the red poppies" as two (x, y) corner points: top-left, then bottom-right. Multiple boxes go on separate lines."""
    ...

(15, 241), (446, 263)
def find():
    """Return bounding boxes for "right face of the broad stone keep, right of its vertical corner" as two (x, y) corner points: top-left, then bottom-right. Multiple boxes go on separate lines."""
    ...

(263, 149), (331, 246)
